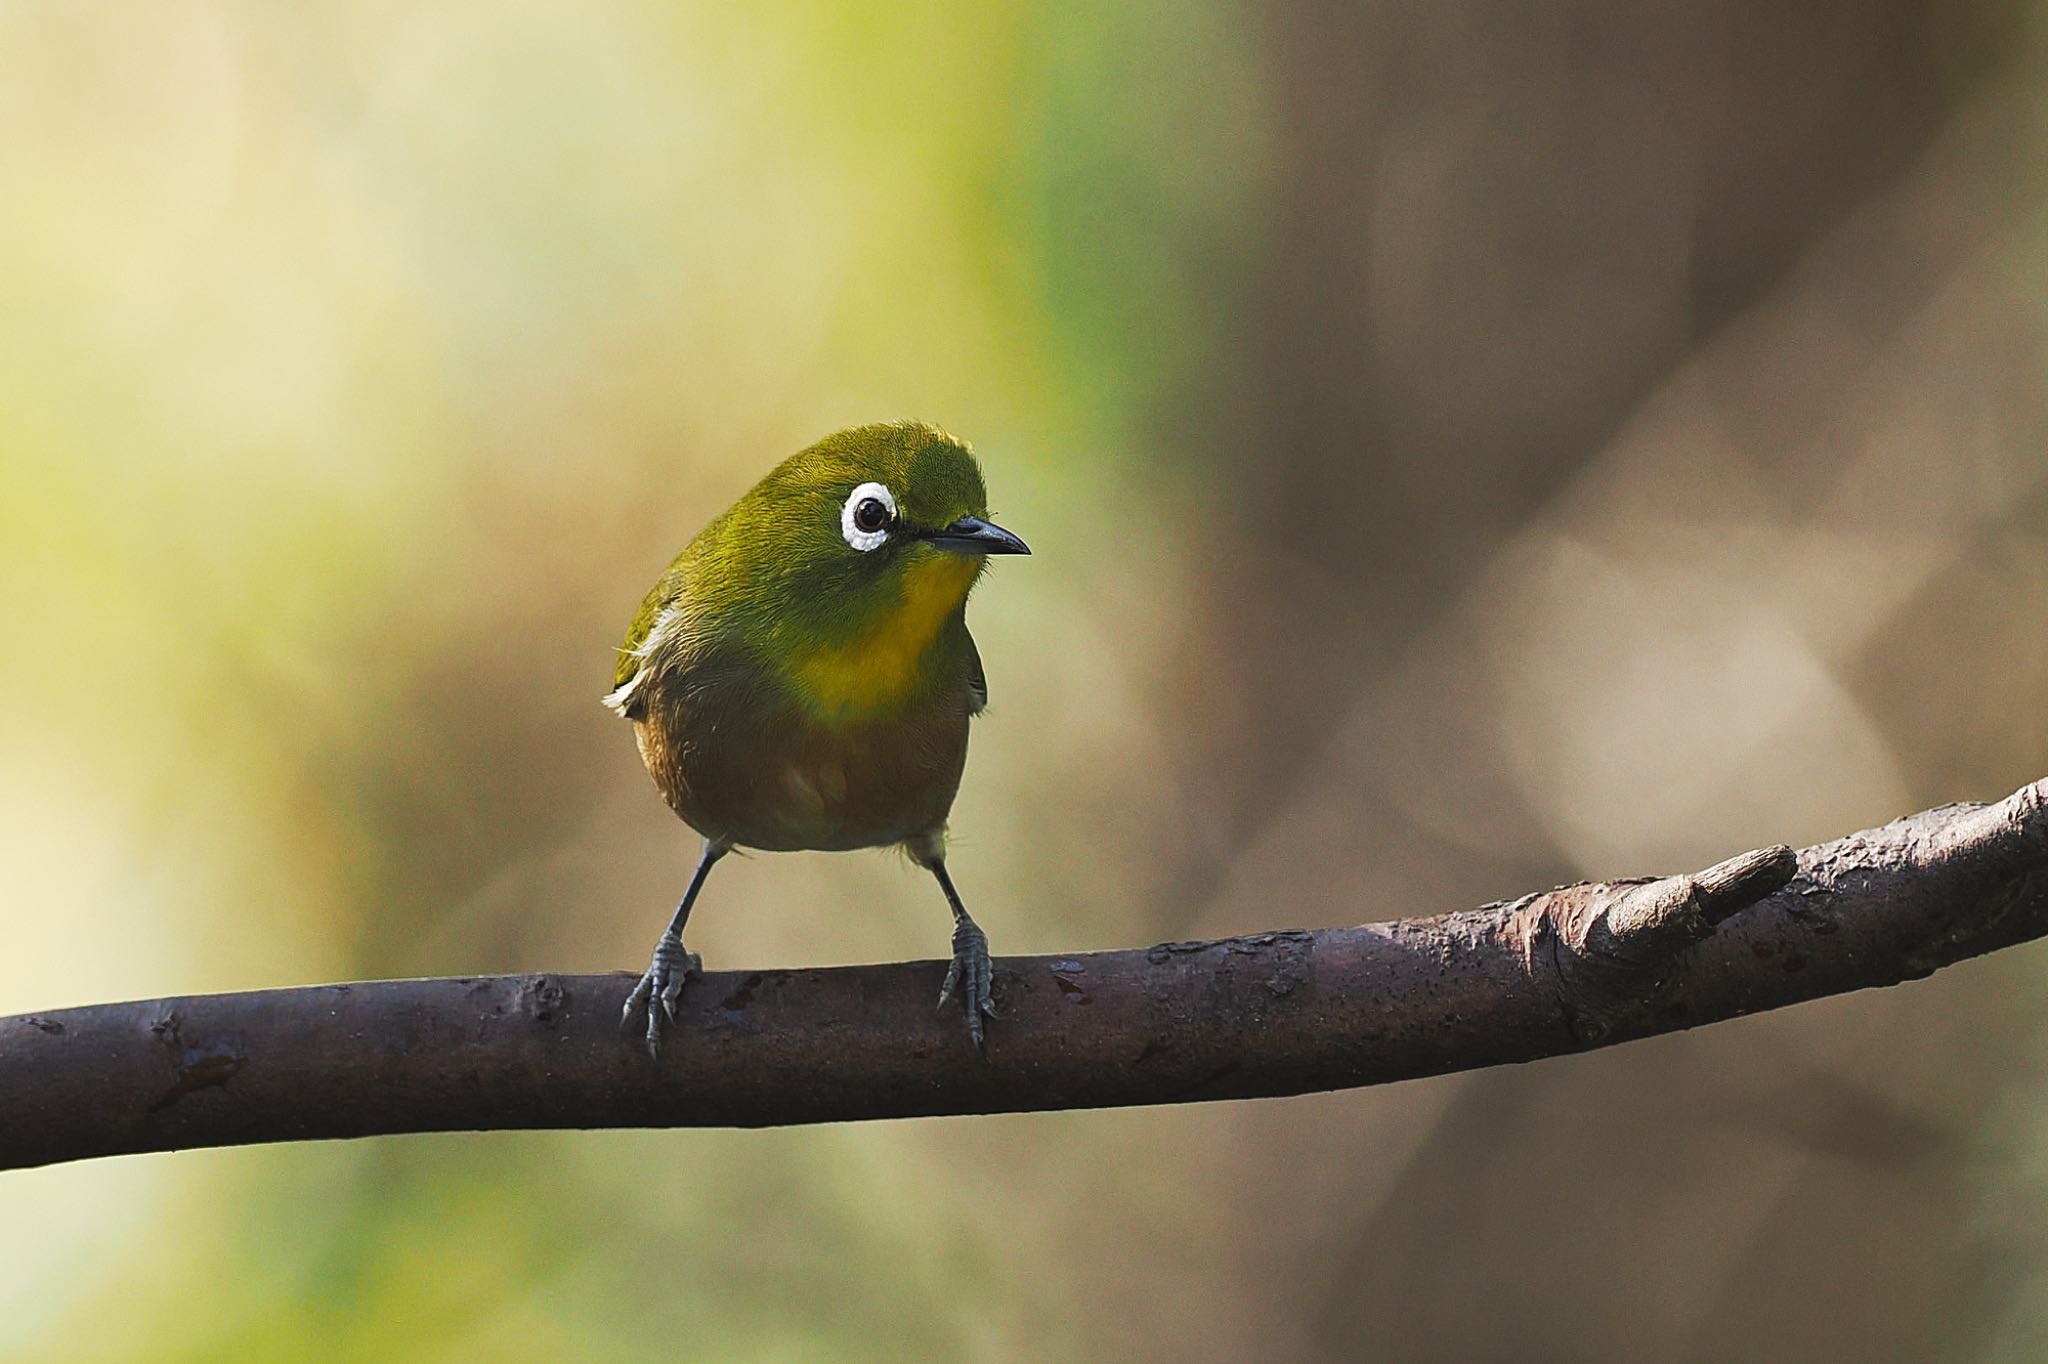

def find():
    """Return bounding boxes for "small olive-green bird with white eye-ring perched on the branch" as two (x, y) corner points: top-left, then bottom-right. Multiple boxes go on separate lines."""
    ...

(604, 422), (1030, 1055)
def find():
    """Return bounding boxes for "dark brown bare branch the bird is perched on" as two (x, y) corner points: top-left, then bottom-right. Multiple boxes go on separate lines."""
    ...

(0, 780), (2048, 1167)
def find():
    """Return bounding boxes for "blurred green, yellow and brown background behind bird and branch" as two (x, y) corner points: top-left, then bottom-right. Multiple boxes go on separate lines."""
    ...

(0, 0), (2048, 1360)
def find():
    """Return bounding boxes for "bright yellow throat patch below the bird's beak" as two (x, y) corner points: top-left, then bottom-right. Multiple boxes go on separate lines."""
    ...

(791, 553), (981, 719)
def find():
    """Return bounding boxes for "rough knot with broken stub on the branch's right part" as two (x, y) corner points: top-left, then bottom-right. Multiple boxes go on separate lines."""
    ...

(1511, 844), (1798, 1040)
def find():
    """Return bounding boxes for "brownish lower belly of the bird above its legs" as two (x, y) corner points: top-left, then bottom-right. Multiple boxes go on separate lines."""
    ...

(639, 692), (967, 852)
